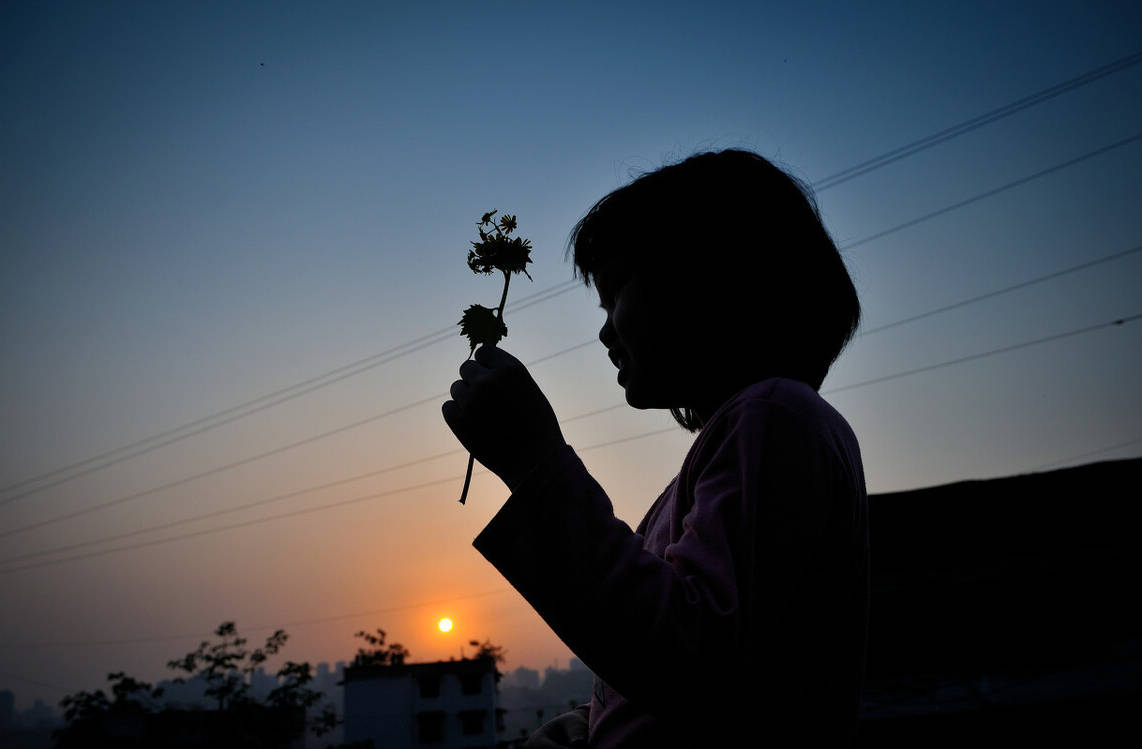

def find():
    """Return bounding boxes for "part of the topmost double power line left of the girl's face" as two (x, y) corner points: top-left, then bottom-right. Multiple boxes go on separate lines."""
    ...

(0, 280), (579, 506)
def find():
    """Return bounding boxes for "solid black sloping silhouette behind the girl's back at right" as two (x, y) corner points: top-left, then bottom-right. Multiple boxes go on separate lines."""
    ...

(857, 458), (1142, 749)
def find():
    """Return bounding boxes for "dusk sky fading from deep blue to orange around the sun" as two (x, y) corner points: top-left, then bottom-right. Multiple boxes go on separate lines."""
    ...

(0, 0), (1142, 708)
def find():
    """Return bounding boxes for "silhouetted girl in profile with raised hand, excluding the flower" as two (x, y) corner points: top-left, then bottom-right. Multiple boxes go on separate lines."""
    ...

(443, 151), (868, 747)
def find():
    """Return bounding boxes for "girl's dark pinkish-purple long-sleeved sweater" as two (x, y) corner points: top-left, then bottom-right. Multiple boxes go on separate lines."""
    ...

(474, 378), (868, 747)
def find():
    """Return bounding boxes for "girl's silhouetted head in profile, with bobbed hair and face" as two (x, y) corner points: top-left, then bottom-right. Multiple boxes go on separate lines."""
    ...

(568, 151), (860, 430)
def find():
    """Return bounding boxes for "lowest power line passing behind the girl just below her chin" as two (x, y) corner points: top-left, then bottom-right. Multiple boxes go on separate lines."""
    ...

(0, 313), (1142, 574)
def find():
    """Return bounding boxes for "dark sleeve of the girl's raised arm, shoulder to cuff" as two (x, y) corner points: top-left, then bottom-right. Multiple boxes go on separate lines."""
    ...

(474, 402), (840, 716)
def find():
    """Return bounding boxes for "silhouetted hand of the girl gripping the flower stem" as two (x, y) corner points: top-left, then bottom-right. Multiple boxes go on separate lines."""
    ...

(441, 346), (566, 491)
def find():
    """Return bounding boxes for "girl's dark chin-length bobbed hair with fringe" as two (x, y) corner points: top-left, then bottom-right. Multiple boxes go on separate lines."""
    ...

(568, 150), (860, 432)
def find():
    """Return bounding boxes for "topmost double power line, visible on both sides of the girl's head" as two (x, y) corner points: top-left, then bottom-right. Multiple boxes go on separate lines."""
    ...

(8, 53), (1142, 506)
